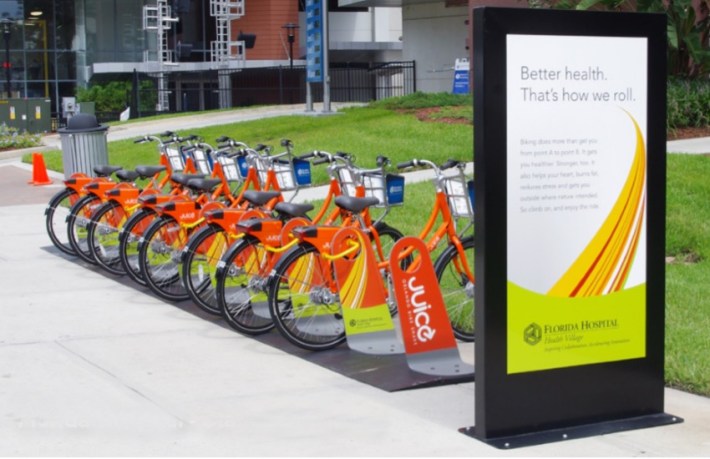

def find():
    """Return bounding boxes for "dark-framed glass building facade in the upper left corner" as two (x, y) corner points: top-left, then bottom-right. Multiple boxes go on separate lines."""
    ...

(0, 0), (215, 114)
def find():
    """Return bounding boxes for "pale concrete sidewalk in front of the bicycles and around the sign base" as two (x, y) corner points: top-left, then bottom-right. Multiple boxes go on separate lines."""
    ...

(0, 108), (710, 457)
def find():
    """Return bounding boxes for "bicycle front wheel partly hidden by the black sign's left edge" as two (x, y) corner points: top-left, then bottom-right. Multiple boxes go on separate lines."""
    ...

(434, 236), (476, 342)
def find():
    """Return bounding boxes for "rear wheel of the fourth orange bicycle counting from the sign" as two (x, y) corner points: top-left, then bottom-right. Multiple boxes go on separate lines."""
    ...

(138, 217), (190, 301)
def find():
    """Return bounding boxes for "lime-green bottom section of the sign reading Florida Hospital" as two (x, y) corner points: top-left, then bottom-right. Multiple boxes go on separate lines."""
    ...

(508, 283), (646, 374)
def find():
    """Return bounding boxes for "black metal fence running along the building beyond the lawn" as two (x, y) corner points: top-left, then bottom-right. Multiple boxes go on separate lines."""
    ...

(96, 61), (417, 122)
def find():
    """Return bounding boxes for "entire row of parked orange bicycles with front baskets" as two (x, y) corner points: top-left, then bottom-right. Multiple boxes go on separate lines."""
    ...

(45, 132), (475, 350)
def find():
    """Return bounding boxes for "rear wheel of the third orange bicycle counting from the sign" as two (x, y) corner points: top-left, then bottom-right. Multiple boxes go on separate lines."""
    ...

(182, 225), (229, 315)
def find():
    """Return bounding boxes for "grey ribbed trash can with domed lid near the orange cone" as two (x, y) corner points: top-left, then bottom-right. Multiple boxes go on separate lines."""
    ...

(58, 113), (108, 178)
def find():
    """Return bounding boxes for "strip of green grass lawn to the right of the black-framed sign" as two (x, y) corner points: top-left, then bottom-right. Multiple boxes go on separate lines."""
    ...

(666, 154), (710, 395)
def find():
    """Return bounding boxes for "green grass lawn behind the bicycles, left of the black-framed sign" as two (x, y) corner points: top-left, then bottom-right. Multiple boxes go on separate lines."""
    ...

(36, 107), (473, 183)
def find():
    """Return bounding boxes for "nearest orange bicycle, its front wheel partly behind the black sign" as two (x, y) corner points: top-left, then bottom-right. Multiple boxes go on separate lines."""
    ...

(268, 160), (474, 351)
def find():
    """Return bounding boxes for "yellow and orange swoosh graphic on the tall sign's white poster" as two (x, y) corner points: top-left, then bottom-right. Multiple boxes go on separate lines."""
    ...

(547, 115), (646, 297)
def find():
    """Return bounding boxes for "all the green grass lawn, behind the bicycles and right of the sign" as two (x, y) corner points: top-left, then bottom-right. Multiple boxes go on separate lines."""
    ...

(32, 97), (710, 396)
